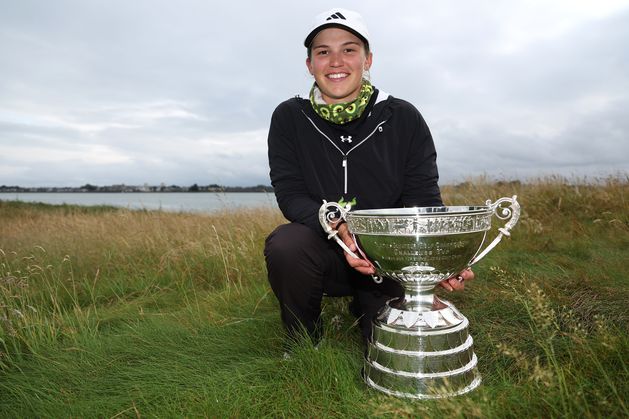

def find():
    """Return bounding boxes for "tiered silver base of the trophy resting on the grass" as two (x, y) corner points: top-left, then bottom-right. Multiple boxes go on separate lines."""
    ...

(363, 300), (481, 399)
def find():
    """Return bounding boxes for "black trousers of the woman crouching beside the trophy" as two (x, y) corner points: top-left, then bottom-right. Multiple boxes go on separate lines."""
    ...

(264, 223), (404, 341)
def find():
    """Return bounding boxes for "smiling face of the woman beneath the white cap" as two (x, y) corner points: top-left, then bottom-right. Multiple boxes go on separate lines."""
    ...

(306, 28), (372, 104)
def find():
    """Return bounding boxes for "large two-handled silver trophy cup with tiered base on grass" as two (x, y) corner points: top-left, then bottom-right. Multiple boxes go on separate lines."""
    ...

(319, 196), (520, 399)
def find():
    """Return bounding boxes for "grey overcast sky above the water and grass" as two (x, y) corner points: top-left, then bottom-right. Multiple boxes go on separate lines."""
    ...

(0, 0), (629, 186)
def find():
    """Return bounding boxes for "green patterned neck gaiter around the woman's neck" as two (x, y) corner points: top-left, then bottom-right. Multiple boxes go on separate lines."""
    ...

(310, 80), (373, 125)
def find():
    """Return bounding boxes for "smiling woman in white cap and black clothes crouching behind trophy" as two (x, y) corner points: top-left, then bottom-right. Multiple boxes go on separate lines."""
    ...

(264, 9), (473, 348)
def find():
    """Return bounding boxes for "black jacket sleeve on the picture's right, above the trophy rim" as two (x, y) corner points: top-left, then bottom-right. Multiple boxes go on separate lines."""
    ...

(402, 107), (443, 207)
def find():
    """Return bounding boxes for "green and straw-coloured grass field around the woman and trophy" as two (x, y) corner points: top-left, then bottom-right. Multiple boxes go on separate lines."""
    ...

(0, 178), (629, 417)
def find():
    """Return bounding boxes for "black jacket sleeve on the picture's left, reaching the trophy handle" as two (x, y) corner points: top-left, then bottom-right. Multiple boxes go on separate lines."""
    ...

(268, 102), (323, 234)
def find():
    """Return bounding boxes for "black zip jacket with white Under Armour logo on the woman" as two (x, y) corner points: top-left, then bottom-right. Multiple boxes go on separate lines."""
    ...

(268, 90), (442, 233)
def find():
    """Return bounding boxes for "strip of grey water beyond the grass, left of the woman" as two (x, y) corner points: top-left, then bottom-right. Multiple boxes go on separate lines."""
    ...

(0, 192), (277, 212)
